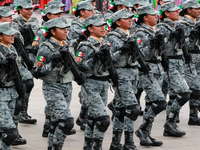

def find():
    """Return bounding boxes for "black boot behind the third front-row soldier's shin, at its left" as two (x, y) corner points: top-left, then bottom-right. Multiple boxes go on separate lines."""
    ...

(76, 106), (88, 131)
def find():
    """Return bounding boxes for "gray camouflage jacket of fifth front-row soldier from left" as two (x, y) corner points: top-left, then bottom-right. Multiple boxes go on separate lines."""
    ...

(135, 24), (164, 74)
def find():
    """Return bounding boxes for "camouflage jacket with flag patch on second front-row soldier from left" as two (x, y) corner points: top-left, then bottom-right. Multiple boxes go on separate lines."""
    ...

(33, 38), (74, 83)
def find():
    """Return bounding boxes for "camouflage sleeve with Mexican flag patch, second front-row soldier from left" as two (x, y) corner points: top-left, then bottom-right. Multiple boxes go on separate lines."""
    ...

(33, 46), (52, 74)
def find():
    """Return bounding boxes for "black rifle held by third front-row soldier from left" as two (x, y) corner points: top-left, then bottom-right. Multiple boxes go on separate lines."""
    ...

(98, 43), (121, 97)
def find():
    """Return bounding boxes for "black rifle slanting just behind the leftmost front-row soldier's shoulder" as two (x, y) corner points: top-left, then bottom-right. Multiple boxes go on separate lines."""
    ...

(13, 34), (33, 71)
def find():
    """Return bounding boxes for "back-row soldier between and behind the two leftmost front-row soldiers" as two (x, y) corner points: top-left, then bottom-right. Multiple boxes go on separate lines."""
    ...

(13, 0), (39, 124)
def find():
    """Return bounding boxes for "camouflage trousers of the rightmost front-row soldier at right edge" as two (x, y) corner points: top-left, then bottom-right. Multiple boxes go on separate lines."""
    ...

(185, 60), (200, 120)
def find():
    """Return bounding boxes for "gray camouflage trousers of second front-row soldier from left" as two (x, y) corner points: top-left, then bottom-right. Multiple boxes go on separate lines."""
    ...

(42, 81), (72, 149)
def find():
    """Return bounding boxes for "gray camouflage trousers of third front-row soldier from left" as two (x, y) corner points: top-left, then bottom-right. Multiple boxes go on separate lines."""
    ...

(81, 78), (109, 146)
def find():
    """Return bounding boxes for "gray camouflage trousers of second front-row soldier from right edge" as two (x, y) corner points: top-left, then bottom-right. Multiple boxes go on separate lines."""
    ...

(164, 59), (190, 117)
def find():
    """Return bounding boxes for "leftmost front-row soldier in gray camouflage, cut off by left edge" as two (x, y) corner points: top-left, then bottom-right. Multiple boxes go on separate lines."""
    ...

(0, 22), (25, 150)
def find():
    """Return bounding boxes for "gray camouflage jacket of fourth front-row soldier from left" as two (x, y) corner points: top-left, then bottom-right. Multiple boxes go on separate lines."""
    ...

(106, 28), (138, 80)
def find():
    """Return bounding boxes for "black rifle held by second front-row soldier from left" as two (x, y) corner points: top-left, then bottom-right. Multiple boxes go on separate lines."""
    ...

(59, 45), (87, 86)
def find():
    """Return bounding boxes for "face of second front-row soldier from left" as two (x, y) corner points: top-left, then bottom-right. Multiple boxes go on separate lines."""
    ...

(51, 28), (67, 41)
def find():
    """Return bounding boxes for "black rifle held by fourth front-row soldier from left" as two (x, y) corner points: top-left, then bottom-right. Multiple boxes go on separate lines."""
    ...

(128, 37), (153, 83)
